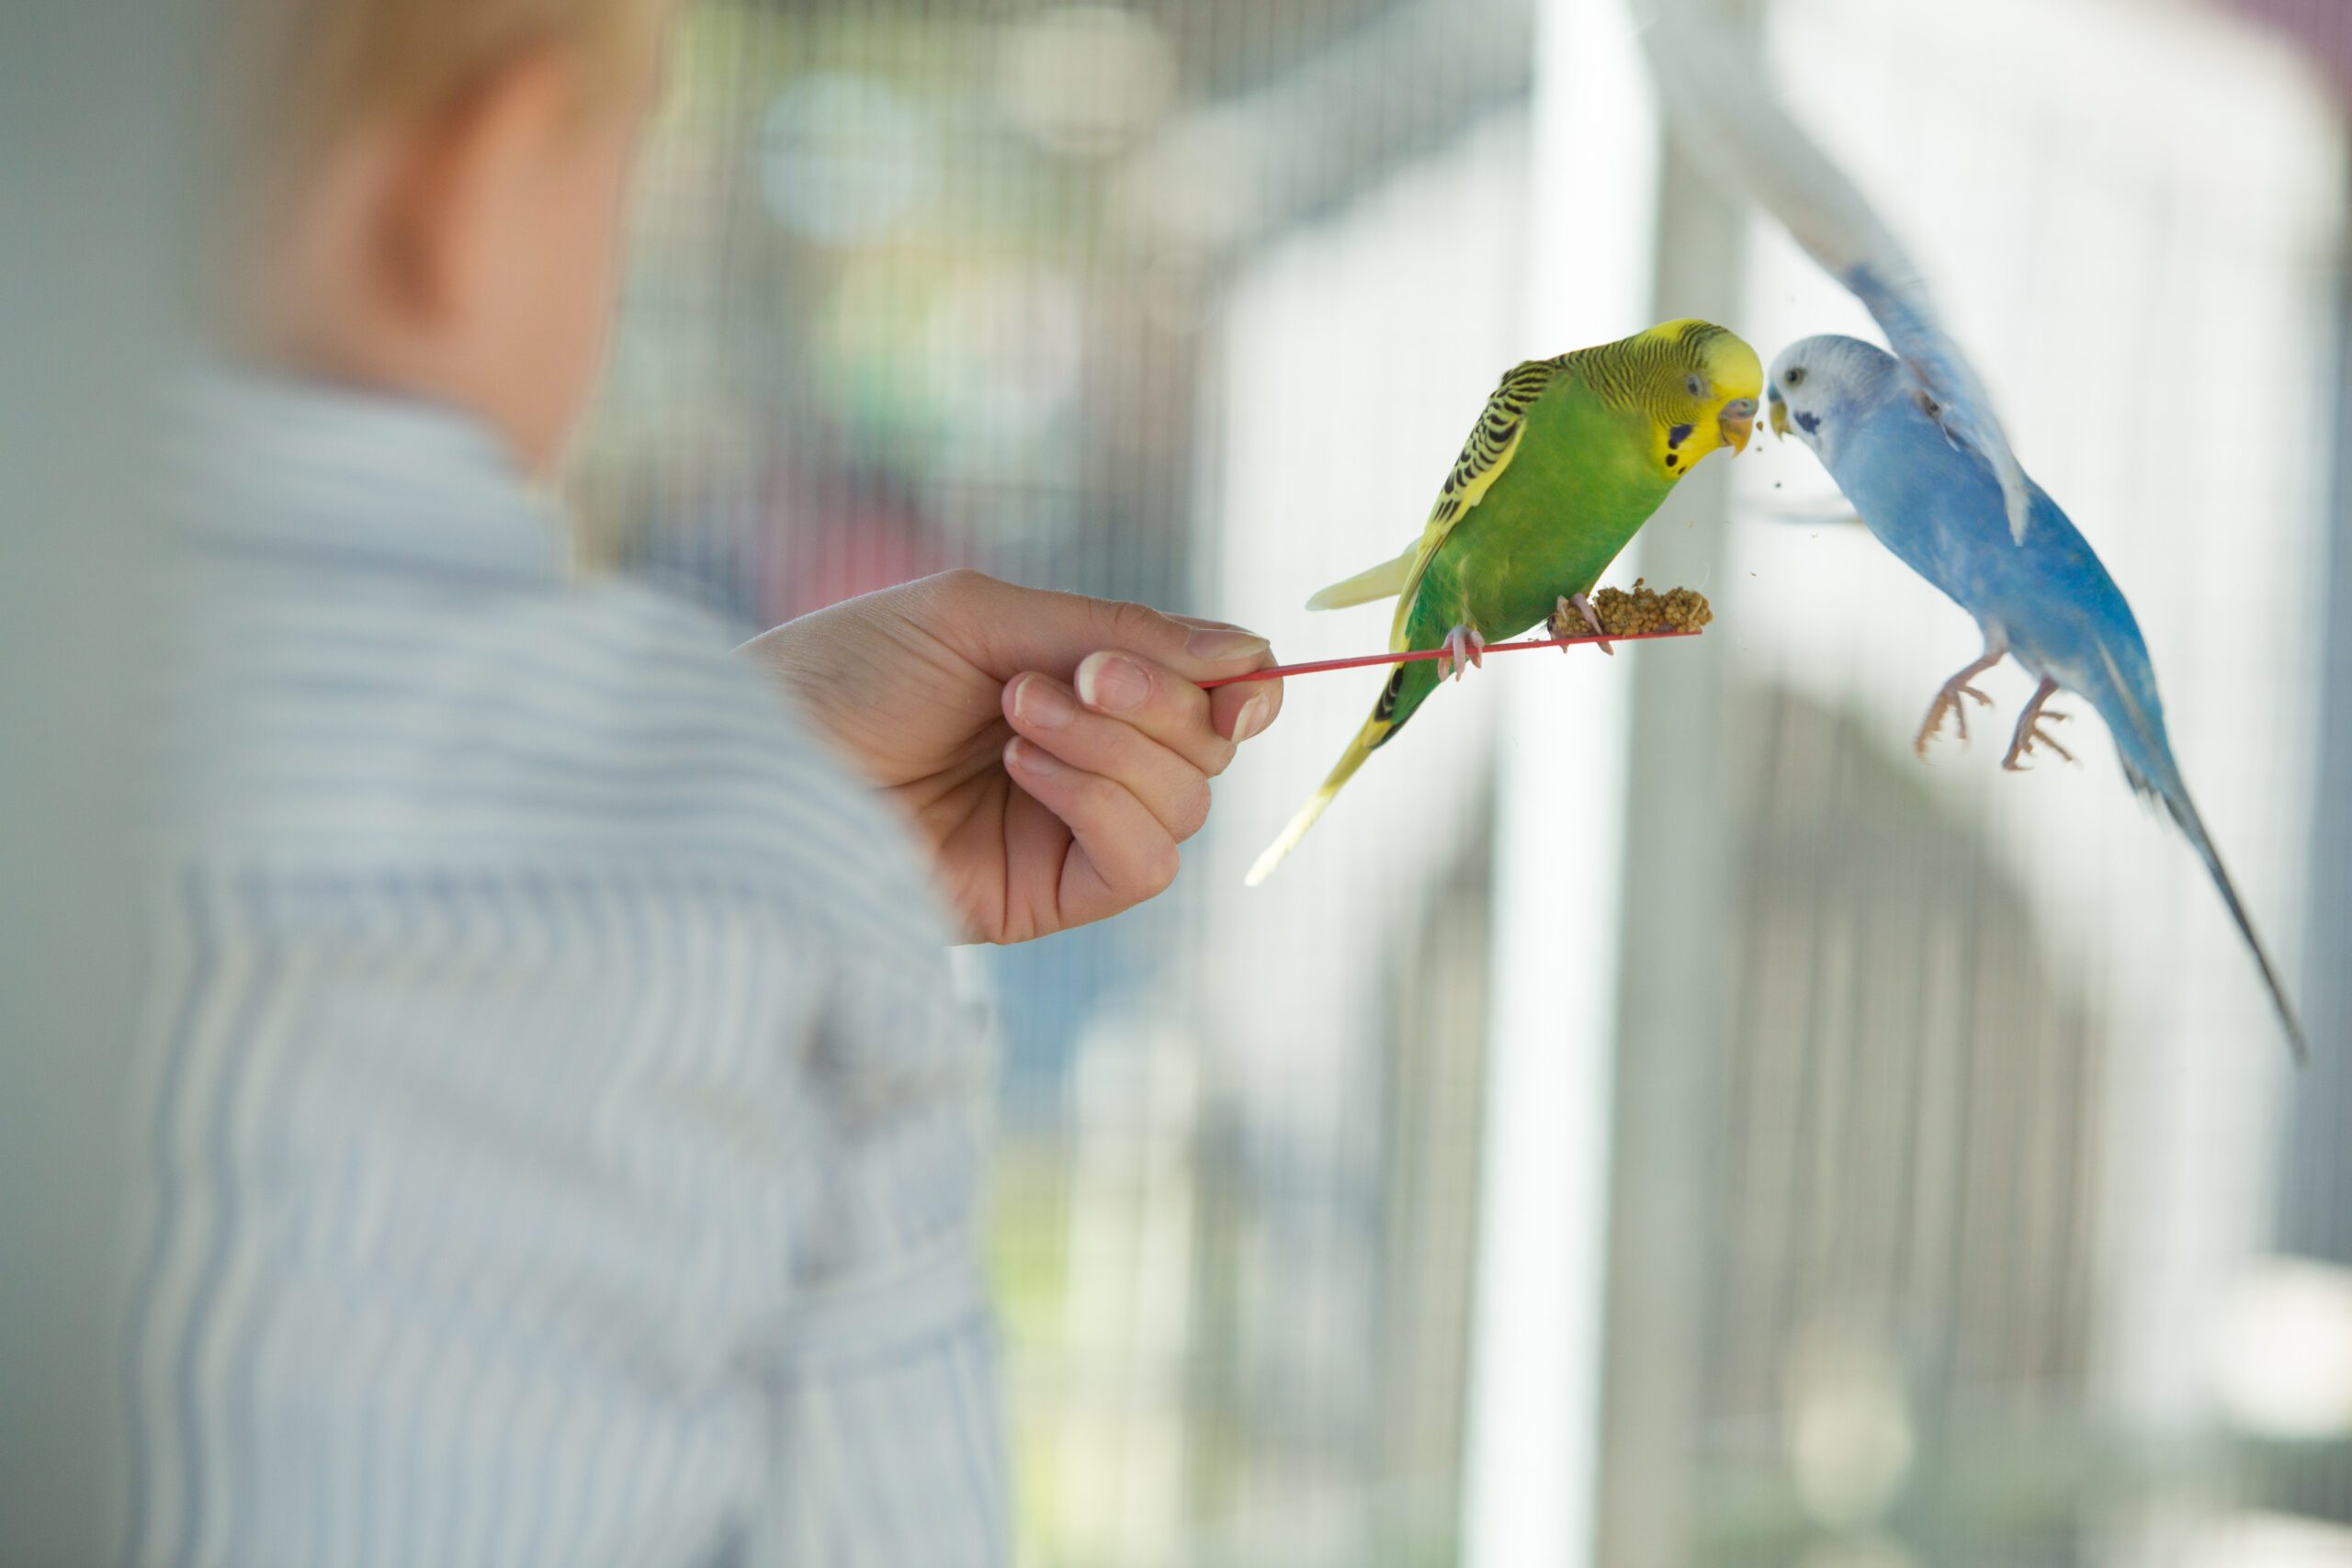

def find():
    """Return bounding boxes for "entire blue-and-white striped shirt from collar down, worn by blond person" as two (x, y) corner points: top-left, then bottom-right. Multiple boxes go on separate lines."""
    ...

(125, 381), (1009, 1568)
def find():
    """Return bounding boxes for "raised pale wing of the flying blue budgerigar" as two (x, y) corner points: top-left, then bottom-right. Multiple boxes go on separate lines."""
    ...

(1633, 0), (2032, 543)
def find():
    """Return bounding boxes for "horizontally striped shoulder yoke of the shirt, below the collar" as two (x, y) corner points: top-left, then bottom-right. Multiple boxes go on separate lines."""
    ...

(174, 564), (945, 941)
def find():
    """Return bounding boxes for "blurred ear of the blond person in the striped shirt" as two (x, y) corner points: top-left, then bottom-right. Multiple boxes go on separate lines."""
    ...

(371, 47), (581, 332)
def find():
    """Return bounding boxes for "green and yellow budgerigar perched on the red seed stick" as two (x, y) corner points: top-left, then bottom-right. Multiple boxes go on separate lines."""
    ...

(1249, 320), (1764, 886)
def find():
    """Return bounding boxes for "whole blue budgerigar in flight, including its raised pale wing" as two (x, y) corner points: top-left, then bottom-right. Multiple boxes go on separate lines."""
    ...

(1630, 0), (2307, 1060)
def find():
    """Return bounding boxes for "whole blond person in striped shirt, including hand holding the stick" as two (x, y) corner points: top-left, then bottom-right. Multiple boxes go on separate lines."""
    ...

(122, 0), (1282, 1568)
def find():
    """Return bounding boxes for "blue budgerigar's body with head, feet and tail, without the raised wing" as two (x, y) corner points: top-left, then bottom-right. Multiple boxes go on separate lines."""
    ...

(1764, 336), (2307, 1060)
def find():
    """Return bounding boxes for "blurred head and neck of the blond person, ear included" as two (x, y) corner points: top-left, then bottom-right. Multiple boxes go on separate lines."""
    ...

(211, 0), (680, 468)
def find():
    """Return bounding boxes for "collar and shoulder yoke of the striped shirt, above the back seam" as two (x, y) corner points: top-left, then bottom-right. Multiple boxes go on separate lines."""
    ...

(158, 371), (944, 949)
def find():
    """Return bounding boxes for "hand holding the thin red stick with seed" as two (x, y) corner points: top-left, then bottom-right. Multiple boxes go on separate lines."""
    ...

(746, 571), (1282, 942)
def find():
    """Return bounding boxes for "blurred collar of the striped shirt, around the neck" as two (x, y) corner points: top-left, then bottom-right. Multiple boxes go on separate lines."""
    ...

(169, 369), (567, 581)
